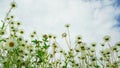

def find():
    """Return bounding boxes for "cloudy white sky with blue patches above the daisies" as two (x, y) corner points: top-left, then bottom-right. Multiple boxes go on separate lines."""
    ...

(0, 0), (120, 47)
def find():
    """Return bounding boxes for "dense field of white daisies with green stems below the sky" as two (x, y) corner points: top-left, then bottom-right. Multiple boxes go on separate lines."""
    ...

(0, 2), (120, 68)
